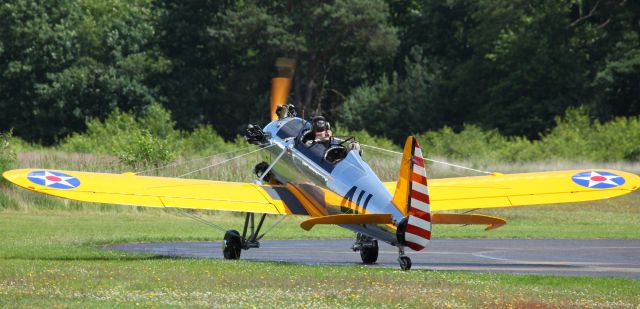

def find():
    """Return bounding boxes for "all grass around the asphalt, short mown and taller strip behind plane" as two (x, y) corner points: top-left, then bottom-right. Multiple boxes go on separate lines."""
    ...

(0, 151), (640, 308)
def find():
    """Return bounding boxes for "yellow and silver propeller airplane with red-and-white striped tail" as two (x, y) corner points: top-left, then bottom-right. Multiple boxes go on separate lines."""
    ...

(3, 59), (640, 270)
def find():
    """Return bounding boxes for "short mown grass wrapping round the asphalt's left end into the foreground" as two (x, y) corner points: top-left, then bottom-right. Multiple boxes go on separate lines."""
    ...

(0, 210), (640, 307)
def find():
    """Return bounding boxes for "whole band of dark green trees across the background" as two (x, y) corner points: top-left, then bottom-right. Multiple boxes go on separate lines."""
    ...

(0, 0), (640, 144)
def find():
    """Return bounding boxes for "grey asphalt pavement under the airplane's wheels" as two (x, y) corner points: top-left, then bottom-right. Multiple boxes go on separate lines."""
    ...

(104, 239), (640, 279)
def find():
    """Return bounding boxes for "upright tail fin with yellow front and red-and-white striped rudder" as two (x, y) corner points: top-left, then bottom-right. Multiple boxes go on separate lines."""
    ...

(393, 136), (431, 251)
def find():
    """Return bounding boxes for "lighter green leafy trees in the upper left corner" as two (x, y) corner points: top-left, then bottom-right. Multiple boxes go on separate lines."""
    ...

(0, 0), (167, 143)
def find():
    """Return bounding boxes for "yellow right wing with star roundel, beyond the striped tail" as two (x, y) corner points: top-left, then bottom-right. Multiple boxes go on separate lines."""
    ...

(385, 169), (640, 210)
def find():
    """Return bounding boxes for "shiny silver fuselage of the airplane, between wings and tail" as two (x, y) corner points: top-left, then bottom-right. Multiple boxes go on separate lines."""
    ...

(264, 118), (404, 245)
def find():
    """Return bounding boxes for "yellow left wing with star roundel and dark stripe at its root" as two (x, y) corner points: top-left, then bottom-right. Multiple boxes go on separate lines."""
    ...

(2, 169), (308, 215)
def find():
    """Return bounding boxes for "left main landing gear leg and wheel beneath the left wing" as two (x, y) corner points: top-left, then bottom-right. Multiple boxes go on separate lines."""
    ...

(222, 213), (267, 260)
